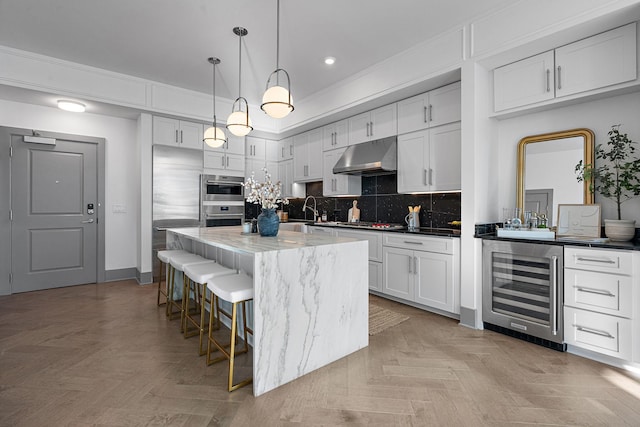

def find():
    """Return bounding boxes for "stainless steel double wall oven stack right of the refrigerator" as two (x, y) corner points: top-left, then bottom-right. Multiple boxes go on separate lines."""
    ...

(200, 175), (244, 227)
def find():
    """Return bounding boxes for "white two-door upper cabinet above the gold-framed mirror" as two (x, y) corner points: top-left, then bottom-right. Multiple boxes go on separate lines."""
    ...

(493, 22), (637, 112)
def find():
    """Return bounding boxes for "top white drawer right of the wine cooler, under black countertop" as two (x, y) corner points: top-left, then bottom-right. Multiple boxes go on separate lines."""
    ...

(564, 246), (633, 275)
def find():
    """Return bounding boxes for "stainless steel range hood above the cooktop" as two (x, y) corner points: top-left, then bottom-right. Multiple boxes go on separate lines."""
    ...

(333, 136), (398, 175)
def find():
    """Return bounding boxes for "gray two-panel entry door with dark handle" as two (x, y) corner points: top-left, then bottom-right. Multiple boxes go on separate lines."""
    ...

(11, 135), (99, 293)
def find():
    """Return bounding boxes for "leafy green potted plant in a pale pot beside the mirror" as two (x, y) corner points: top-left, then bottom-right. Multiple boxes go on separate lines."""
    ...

(575, 125), (640, 241)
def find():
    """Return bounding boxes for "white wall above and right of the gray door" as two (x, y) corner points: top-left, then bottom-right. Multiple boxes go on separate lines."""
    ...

(0, 100), (140, 271)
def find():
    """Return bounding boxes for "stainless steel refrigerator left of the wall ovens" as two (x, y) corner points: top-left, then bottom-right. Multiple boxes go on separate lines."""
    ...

(152, 145), (203, 281)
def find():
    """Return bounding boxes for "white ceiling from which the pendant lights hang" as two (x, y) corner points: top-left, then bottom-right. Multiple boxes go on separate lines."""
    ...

(0, 0), (511, 110)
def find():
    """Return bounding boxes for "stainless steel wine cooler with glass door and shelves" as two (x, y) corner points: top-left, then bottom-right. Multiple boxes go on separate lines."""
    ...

(482, 240), (566, 351)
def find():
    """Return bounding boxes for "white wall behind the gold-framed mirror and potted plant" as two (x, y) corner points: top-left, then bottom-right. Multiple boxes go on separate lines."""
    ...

(493, 93), (640, 226)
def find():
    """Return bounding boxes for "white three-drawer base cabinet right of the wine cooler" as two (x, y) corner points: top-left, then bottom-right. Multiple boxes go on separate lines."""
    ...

(564, 246), (638, 361)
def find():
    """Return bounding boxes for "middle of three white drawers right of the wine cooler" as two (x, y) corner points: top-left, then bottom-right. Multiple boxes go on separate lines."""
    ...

(564, 269), (632, 318)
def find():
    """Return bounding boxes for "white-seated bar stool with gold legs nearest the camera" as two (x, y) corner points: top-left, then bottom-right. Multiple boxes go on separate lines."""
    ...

(207, 273), (253, 392)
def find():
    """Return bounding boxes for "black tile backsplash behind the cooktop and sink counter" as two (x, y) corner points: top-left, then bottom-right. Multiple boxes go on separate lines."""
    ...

(245, 174), (460, 228)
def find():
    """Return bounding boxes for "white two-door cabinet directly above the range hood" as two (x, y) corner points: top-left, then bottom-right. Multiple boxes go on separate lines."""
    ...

(348, 103), (398, 145)
